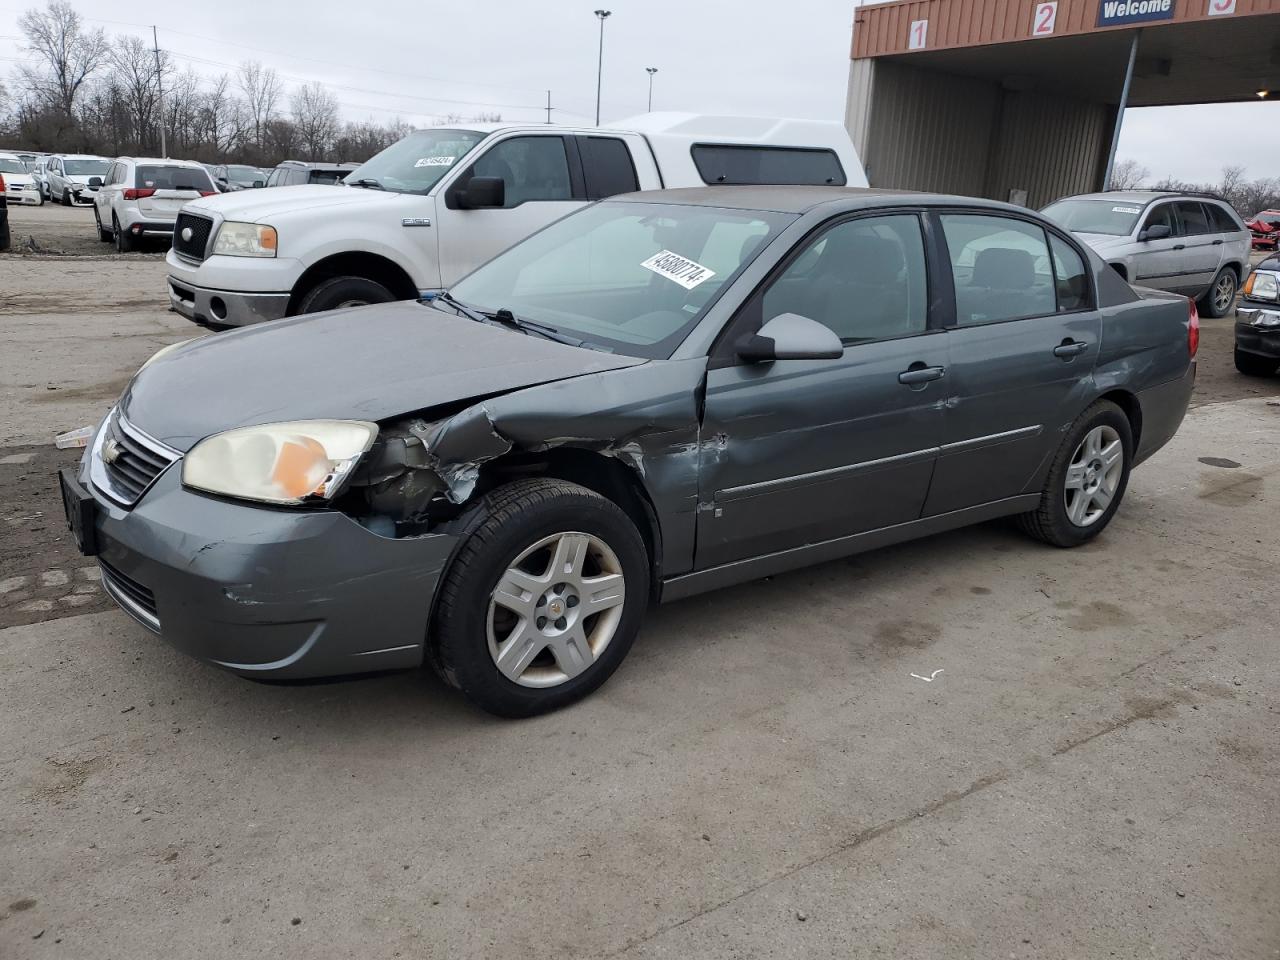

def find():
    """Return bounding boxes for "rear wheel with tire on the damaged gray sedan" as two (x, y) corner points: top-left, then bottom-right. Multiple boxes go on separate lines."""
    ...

(1018, 401), (1133, 547)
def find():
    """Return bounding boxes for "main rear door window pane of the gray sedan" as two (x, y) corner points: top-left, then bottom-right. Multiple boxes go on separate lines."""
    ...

(941, 214), (1057, 326)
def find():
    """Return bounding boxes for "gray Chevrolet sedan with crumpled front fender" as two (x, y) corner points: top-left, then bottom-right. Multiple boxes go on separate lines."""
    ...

(61, 187), (1198, 716)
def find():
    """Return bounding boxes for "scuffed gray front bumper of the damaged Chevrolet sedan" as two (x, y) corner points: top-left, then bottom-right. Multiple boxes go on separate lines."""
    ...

(79, 448), (456, 678)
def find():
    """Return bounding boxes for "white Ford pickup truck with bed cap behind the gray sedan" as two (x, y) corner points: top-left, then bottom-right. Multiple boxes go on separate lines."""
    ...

(168, 114), (867, 326)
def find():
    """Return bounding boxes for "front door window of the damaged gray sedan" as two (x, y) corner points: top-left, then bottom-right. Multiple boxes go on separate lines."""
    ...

(762, 214), (928, 343)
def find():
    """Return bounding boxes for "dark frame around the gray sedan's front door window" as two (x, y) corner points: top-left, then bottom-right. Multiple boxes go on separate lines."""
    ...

(707, 205), (955, 370)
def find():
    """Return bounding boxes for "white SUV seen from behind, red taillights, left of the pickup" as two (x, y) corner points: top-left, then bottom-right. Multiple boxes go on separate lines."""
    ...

(93, 156), (218, 253)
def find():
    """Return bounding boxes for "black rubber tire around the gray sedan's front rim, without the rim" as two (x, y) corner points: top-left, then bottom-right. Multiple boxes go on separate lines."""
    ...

(433, 490), (649, 717)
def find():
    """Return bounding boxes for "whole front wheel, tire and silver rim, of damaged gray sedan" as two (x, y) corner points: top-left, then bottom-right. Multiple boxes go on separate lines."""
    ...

(428, 479), (649, 717)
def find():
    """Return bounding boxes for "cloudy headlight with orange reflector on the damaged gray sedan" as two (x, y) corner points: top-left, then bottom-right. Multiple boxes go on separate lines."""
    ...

(182, 420), (378, 512)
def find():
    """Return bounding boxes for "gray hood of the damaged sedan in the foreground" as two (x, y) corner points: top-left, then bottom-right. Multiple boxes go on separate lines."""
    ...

(120, 299), (645, 452)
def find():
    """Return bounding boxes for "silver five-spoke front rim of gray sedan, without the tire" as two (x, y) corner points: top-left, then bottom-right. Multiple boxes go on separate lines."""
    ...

(486, 531), (626, 687)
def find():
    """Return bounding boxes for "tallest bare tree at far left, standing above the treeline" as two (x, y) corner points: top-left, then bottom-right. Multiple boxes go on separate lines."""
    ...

(18, 0), (108, 122)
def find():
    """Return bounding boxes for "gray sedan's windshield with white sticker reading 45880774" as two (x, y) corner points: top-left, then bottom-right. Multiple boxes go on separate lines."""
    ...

(449, 202), (795, 358)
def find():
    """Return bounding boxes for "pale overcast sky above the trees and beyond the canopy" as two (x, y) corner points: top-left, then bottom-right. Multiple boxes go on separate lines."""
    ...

(0, 0), (1280, 180)
